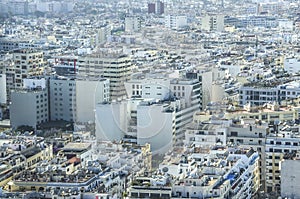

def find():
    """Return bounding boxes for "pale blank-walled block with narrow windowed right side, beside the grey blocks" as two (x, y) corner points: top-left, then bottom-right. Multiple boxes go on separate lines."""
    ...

(75, 78), (110, 123)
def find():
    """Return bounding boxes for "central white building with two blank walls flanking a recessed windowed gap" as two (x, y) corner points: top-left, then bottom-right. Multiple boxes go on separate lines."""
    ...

(95, 99), (175, 154)
